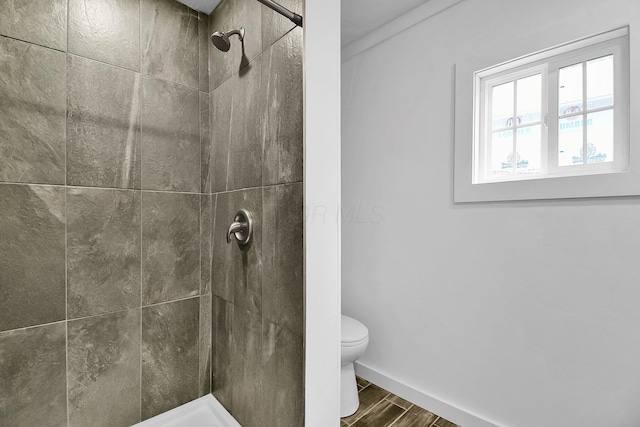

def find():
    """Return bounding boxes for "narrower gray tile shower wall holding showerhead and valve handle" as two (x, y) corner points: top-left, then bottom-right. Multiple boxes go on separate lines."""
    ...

(202, 0), (304, 427)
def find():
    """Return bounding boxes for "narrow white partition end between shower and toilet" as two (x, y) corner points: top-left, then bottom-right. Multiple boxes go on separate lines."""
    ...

(304, 0), (340, 427)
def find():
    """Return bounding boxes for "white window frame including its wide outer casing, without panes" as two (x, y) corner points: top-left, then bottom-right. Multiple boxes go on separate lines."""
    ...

(453, 27), (640, 203)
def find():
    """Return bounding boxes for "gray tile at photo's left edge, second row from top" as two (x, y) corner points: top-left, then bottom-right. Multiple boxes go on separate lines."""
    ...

(0, 38), (66, 184)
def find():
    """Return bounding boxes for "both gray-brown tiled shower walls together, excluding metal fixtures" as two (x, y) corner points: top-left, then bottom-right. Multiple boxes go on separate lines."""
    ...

(0, 0), (304, 427)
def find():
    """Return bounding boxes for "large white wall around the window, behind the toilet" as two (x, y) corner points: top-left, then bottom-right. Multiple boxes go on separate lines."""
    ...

(342, 0), (640, 427)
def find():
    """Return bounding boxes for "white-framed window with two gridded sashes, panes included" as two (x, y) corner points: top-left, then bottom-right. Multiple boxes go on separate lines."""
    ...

(472, 28), (629, 185)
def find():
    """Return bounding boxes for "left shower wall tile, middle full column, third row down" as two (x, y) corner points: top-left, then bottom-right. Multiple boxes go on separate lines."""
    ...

(67, 188), (140, 318)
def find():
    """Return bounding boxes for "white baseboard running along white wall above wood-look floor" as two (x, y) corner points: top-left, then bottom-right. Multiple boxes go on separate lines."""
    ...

(355, 362), (500, 427)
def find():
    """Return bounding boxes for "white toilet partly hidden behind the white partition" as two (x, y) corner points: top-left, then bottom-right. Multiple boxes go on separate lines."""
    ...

(340, 314), (369, 417)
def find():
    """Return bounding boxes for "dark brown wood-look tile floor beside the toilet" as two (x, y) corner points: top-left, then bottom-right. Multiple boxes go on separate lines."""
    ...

(340, 377), (459, 427)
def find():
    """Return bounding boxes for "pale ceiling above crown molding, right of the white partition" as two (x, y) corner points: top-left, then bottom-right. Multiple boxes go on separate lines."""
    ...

(342, 0), (427, 46)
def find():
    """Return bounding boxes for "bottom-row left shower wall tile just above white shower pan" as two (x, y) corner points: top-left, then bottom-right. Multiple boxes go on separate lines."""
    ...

(142, 298), (200, 419)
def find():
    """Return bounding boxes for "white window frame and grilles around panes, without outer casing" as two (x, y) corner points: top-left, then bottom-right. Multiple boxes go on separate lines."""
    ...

(473, 29), (629, 185)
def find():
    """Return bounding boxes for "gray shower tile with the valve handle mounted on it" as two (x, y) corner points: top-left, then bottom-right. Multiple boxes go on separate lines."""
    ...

(211, 188), (262, 313)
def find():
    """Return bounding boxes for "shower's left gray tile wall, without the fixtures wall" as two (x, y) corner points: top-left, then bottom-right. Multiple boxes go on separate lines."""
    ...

(0, 0), (214, 426)
